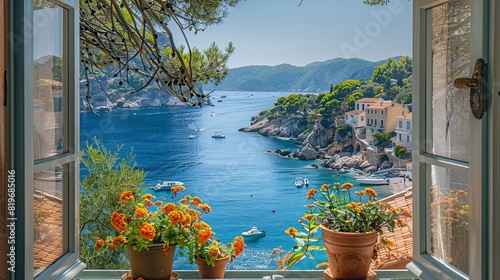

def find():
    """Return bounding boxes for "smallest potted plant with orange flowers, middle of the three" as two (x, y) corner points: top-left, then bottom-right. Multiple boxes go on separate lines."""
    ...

(189, 233), (246, 279)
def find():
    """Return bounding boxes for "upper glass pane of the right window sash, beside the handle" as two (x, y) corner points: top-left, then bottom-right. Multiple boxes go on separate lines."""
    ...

(427, 1), (470, 161)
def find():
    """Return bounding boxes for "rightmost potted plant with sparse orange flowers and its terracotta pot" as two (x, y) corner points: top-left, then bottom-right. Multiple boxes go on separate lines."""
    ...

(275, 183), (411, 279)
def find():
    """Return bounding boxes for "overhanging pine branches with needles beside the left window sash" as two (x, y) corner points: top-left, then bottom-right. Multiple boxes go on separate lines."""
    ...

(78, 0), (239, 105)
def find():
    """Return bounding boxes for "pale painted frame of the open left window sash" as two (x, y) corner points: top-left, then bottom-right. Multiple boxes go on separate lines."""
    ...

(8, 0), (85, 279)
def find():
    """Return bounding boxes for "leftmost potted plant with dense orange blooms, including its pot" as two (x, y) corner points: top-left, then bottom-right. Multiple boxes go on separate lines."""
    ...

(95, 186), (211, 280)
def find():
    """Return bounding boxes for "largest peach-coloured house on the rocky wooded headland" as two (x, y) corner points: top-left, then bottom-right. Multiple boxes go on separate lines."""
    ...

(365, 101), (409, 145)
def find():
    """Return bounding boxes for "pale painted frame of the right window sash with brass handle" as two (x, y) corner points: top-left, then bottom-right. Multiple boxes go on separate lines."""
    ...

(407, 0), (490, 279)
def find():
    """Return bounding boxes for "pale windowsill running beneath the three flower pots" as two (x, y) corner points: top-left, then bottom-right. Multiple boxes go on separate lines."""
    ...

(76, 269), (419, 280)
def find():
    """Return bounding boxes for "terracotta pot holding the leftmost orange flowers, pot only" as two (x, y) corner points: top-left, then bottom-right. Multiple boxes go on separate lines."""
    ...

(127, 244), (175, 280)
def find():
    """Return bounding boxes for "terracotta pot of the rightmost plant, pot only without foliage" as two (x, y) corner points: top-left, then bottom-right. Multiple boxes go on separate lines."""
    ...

(320, 225), (378, 279)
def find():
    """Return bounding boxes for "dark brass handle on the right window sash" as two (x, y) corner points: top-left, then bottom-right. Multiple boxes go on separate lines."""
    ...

(454, 58), (486, 120)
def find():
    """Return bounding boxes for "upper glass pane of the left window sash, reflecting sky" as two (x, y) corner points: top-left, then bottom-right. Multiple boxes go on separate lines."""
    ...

(33, 0), (64, 160)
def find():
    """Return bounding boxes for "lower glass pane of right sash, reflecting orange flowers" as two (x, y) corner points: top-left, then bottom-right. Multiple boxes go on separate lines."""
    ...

(431, 166), (469, 274)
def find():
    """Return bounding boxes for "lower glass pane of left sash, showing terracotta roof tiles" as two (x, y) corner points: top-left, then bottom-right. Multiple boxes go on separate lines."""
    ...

(33, 167), (65, 276)
